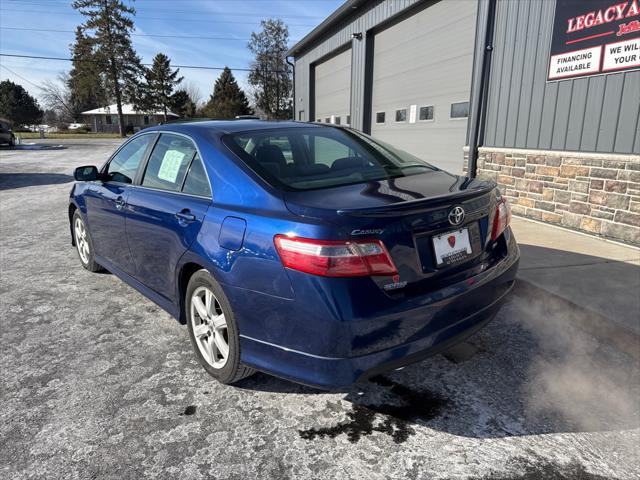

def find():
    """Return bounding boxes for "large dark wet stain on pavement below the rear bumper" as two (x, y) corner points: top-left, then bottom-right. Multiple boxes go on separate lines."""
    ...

(299, 376), (450, 443)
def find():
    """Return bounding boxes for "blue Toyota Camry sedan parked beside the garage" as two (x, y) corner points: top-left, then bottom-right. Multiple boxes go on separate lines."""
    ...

(69, 120), (519, 389)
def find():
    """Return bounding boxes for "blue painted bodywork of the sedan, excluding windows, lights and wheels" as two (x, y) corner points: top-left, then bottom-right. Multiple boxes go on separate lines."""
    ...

(70, 121), (519, 388)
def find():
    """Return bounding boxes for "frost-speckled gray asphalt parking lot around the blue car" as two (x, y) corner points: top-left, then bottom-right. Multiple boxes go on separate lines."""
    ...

(0, 140), (640, 480)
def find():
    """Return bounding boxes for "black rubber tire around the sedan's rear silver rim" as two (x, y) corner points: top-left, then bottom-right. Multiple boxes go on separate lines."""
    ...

(184, 270), (255, 384)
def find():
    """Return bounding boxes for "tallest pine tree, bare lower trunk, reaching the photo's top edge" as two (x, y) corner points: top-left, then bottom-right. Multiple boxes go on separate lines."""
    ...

(72, 0), (143, 137)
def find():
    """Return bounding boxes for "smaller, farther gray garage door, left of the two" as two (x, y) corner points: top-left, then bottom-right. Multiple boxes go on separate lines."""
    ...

(313, 49), (351, 125)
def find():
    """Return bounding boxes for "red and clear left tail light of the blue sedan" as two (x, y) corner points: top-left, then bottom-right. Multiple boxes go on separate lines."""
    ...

(274, 235), (398, 277)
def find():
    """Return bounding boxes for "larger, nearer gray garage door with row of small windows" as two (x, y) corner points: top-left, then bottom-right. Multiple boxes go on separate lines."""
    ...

(371, 1), (477, 173)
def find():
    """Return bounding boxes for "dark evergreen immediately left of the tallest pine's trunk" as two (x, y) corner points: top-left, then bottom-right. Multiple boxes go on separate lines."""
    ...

(66, 27), (109, 112)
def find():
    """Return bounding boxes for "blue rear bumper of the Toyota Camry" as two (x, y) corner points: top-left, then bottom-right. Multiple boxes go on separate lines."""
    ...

(231, 239), (519, 389)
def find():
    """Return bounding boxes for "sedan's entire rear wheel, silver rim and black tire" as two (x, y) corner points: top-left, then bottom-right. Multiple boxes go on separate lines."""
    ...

(185, 270), (254, 384)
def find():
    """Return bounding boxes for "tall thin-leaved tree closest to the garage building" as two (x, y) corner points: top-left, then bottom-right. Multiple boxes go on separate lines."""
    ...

(248, 19), (293, 119)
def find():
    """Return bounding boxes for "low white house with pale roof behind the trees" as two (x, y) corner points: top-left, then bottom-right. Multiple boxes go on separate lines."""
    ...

(82, 103), (179, 133)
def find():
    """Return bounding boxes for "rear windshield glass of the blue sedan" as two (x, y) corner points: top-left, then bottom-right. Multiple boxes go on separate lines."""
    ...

(223, 127), (437, 190)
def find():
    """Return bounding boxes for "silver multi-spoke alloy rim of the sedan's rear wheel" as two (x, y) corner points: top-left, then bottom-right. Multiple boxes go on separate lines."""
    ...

(190, 287), (229, 369)
